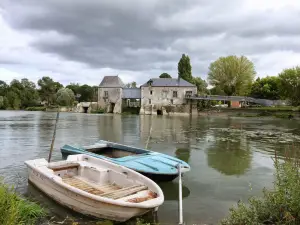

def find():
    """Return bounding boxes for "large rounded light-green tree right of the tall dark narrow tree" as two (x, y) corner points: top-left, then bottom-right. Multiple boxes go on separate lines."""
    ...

(208, 56), (256, 96)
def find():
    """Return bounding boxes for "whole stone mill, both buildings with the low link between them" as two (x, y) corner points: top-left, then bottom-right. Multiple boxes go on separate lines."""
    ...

(98, 76), (197, 115)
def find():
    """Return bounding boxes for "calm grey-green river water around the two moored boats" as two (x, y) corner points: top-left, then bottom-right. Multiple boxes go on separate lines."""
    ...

(0, 111), (300, 224)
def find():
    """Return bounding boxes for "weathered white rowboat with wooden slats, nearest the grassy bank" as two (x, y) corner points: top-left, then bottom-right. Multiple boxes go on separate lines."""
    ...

(25, 154), (164, 222)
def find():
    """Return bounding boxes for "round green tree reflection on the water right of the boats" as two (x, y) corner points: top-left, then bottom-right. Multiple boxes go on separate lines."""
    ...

(207, 139), (252, 175)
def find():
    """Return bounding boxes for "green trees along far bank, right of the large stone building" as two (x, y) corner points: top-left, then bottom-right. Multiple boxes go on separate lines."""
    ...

(159, 54), (300, 106)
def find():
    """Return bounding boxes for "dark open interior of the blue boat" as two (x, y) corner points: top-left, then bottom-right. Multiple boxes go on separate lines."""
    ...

(85, 146), (146, 158)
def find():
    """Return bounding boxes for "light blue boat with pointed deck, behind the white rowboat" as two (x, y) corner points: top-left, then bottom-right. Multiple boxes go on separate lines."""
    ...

(61, 140), (190, 181)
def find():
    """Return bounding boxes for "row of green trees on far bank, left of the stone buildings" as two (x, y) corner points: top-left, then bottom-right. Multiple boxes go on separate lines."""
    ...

(0, 77), (98, 109)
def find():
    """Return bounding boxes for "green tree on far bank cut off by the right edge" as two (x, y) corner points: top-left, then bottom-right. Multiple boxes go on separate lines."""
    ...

(279, 66), (300, 106)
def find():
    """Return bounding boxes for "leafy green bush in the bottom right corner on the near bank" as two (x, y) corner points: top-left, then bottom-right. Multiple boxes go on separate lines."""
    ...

(221, 157), (300, 225)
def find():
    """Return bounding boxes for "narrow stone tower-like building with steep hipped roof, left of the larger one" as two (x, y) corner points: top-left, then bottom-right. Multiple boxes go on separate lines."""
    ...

(98, 76), (125, 113)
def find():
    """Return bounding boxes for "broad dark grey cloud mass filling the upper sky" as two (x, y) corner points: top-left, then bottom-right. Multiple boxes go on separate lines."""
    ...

(2, 0), (300, 78)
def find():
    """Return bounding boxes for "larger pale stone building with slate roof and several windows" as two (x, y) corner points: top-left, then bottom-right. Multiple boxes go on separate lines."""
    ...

(140, 78), (197, 115)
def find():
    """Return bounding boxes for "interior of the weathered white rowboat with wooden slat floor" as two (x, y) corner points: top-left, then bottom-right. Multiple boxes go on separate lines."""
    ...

(48, 162), (157, 203)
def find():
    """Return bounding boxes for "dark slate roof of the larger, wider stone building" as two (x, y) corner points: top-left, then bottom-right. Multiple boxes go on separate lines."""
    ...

(141, 78), (196, 87)
